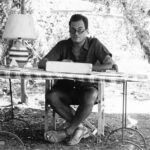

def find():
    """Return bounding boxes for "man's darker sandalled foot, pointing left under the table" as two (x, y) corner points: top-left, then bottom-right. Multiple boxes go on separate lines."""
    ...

(44, 130), (69, 143)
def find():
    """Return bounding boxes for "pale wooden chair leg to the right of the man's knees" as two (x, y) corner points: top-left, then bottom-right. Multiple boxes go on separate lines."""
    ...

(98, 81), (105, 136)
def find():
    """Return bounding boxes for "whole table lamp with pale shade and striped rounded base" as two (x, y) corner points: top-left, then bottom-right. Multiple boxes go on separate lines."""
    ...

(2, 14), (36, 67)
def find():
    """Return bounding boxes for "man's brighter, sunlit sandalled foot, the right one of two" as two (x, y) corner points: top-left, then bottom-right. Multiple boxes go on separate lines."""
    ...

(67, 127), (89, 146)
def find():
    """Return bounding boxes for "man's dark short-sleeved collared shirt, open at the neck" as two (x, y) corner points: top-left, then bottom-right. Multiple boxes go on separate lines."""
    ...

(42, 37), (112, 65)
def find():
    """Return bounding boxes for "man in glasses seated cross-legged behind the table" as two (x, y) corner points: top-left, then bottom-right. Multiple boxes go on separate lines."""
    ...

(39, 14), (118, 145)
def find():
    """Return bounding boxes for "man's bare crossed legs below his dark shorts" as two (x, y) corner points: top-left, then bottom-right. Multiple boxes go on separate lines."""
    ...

(47, 88), (97, 135)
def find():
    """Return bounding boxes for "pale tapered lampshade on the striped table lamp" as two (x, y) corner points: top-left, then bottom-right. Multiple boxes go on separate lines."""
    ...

(2, 14), (36, 40)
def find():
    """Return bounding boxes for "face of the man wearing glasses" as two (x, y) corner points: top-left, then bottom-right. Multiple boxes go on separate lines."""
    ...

(69, 20), (88, 43)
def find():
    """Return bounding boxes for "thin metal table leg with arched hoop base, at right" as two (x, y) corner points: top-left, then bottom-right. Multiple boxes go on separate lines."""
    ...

(106, 81), (146, 150)
